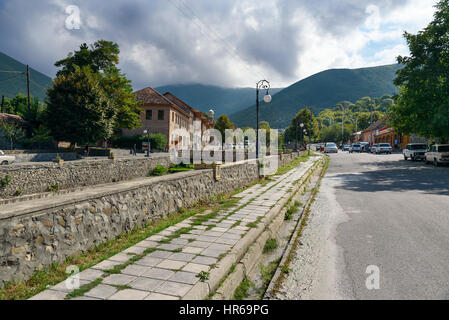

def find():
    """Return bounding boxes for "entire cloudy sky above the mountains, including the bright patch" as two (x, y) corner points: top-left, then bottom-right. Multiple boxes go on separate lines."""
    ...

(0, 0), (436, 89)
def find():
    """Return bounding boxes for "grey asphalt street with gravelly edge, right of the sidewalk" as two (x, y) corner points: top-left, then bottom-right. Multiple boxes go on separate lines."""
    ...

(278, 152), (449, 299)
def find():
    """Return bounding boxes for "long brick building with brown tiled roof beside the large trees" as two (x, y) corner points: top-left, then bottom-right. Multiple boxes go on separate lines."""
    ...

(122, 87), (213, 150)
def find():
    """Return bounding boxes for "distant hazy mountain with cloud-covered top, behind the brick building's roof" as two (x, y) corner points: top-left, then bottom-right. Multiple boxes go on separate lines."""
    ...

(155, 84), (282, 117)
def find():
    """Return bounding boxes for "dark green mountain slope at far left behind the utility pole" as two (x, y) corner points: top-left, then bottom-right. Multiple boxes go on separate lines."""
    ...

(0, 52), (51, 101)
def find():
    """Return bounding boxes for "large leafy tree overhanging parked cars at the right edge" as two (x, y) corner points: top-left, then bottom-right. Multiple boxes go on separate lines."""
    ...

(390, 0), (449, 142)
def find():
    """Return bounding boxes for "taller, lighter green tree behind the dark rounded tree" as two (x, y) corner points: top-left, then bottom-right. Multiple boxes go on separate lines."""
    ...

(55, 40), (141, 130)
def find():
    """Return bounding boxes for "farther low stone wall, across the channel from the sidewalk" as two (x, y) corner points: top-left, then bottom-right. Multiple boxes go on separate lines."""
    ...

(0, 155), (171, 199)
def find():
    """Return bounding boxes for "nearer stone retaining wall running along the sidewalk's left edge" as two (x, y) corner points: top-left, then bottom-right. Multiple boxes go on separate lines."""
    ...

(0, 154), (297, 287)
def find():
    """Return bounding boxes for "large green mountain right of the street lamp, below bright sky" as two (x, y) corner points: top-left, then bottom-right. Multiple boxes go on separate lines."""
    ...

(230, 64), (401, 128)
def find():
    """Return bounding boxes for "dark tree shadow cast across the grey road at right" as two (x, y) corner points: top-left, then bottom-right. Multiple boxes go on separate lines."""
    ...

(334, 160), (449, 195)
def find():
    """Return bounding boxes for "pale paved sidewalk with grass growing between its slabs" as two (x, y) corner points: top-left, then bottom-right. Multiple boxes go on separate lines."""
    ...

(31, 157), (318, 300)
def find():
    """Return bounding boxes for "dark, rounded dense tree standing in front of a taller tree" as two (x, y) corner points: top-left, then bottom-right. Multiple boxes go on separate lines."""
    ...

(45, 67), (116, 147)
